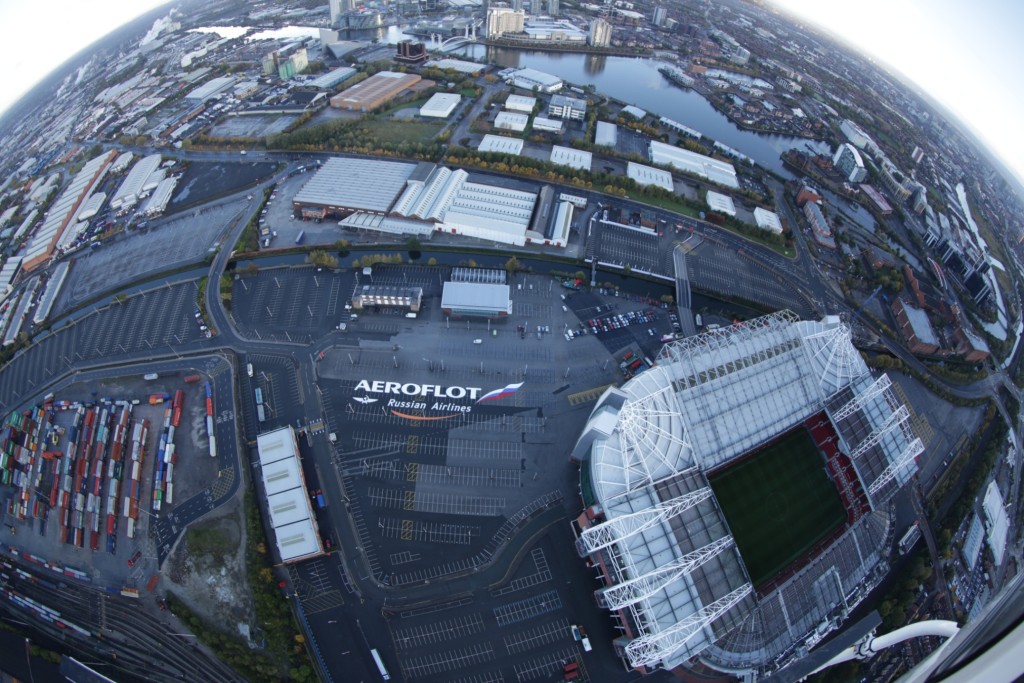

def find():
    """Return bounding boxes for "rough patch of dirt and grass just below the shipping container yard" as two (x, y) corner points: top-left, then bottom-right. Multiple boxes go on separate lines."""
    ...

(164, 499), (255, 633)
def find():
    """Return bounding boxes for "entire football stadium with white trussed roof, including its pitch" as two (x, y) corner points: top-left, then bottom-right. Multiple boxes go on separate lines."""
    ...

(572, 311), (924, 676)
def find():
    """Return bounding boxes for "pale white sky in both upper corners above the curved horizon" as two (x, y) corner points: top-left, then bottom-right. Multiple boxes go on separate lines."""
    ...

(0, 0), (1024, 180)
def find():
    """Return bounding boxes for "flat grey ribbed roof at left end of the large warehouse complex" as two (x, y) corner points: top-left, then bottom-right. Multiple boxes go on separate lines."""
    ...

(293, 157), (417, 213)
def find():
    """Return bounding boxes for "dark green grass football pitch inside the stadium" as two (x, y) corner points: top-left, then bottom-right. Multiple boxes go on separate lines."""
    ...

(710, 429), (846, 586)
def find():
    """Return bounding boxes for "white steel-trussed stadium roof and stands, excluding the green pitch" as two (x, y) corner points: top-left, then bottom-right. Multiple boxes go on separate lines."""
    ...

(572, 311), (922, 673)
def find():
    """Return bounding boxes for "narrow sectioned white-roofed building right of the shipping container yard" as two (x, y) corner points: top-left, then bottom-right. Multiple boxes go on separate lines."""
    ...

(256, 427), (324, 564)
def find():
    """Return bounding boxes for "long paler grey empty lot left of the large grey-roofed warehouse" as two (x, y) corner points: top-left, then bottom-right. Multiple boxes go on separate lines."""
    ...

(53, 199), (249, 316)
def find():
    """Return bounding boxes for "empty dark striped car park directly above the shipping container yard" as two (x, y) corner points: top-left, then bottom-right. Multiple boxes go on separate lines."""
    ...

(0, 283), (204, 407)
